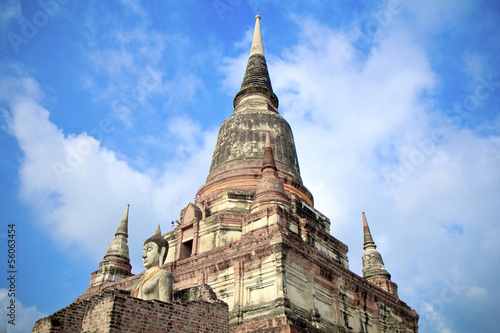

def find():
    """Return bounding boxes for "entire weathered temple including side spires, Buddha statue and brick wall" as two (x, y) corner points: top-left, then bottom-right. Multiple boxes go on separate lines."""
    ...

(33, 15), (418, 333)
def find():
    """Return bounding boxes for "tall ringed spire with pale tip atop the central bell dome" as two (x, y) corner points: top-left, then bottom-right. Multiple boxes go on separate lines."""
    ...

(233, 15), (278, 109)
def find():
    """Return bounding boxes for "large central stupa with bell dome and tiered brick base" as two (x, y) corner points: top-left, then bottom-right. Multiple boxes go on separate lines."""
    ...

(164, 16), (418, 333)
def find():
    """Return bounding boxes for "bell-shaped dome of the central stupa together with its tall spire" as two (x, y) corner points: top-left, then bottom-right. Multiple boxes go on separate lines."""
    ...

(197, 15), (314, 206)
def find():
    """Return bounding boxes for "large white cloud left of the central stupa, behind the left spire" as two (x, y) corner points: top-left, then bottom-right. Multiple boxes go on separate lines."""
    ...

(1, 69), (215, 271)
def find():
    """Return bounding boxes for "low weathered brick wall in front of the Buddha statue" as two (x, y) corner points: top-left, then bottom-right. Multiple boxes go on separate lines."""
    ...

(32, 291), (229, 333)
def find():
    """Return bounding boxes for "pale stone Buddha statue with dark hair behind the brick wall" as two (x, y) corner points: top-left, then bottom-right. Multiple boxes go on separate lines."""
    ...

(131, 225), (174, 302)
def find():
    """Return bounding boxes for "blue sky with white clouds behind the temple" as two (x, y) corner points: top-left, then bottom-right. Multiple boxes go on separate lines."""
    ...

(0, 0), (500, 333)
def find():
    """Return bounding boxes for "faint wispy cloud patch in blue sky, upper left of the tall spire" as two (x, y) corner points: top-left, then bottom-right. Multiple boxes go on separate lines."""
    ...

(82, 27), (169, 127)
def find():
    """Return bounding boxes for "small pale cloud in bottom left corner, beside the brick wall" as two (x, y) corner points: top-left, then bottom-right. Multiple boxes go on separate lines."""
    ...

(0, 288), (47, 333)
